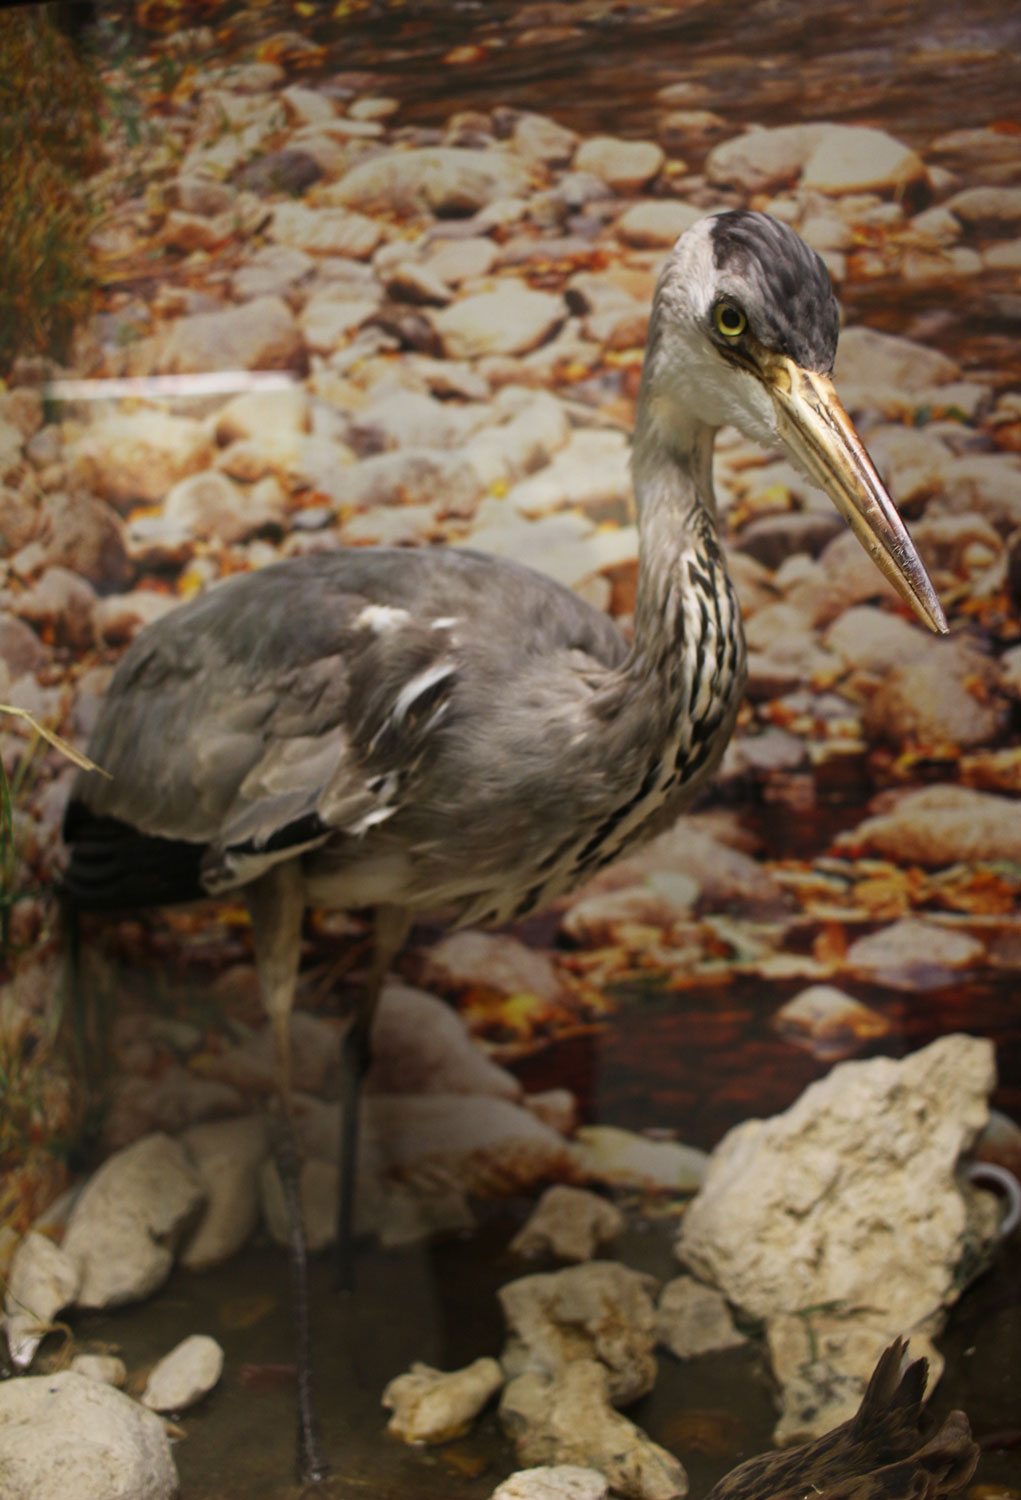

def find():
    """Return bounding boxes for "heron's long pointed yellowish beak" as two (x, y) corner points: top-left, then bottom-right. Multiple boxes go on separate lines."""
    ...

(759, 357), (946, 635)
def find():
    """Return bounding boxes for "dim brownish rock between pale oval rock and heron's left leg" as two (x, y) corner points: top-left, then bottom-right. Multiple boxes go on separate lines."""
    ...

(180, 1115), (270, 1271)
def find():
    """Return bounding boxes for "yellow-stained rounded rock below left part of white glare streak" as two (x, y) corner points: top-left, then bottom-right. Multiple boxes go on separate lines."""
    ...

(73, 411), (213, 510)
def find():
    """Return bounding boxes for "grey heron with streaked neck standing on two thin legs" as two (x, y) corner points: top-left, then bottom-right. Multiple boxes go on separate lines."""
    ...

(66, 210), (946, 1476)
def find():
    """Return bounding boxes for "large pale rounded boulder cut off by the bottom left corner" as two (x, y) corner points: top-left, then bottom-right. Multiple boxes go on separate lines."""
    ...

(0, 1370), (177, 1500)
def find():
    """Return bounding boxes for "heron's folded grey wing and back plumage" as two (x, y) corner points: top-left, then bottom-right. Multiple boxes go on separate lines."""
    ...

(73, 549), (622, 891)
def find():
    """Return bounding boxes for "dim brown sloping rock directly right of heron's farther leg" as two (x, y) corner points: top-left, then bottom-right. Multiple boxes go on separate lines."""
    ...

(366, 980), (522, 1100)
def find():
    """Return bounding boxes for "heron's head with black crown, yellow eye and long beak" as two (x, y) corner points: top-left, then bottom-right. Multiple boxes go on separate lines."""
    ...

(643, 209), (946, 632)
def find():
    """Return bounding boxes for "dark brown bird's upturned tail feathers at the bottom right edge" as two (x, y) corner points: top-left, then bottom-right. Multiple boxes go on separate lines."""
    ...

(706, 1338), (979, 1500)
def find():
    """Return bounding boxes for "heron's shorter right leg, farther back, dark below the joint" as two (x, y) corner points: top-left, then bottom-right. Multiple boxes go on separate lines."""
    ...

(337, 906), (411, 1292)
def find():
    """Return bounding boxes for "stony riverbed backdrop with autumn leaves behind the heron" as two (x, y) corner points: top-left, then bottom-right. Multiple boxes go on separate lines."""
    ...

(0, 5), (1021, 1496)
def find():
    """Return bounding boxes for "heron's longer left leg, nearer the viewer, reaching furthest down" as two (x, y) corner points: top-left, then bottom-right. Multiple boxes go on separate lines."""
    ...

(244, 861), (330, 1485)
